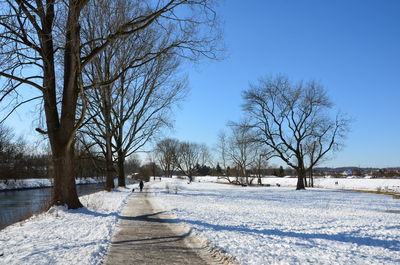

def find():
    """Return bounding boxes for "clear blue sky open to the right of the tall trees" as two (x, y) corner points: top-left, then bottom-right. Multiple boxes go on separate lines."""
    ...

(166, 0), (400, 167)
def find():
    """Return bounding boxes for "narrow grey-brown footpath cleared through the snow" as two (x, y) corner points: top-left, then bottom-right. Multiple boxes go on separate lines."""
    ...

(105, 187), (227, 265)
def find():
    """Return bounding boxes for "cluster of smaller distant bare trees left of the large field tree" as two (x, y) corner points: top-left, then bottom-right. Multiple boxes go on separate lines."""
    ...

(154, 135), (276, 185)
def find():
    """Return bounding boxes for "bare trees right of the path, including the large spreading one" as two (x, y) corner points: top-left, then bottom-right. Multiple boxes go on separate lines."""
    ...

(152, 75), (350, 189)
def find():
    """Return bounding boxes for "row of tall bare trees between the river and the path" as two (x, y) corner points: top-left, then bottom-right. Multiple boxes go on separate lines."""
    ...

(0, 0), (220, 209)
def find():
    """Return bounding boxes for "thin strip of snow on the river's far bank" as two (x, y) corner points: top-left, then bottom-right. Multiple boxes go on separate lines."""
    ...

(0, 178), (104, 191)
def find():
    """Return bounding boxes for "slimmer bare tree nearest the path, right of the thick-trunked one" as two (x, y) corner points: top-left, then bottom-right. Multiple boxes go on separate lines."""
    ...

(113, 55), (186, 186)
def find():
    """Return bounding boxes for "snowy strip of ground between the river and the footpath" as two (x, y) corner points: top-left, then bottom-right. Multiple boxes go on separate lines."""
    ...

(0, 187), (132, 265)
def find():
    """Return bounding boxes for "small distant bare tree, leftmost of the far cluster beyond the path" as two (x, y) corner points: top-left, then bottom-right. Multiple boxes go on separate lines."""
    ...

(155, 138), (179, 178)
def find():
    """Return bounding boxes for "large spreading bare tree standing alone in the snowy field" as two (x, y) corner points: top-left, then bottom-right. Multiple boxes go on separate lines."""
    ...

(243, 75), (349, 189)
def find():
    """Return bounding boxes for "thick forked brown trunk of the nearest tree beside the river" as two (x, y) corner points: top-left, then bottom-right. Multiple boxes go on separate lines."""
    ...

(44, 0), (87, 209)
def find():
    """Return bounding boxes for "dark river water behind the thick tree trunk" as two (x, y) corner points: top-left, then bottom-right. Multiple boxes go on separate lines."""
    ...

(0, 183), (104, 229)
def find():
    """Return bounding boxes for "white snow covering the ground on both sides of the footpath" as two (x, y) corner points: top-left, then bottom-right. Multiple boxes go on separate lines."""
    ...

(0, 177), (400, 265)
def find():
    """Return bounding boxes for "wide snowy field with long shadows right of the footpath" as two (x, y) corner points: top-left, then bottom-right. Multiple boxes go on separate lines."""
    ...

(152, 178), (400, 264)
